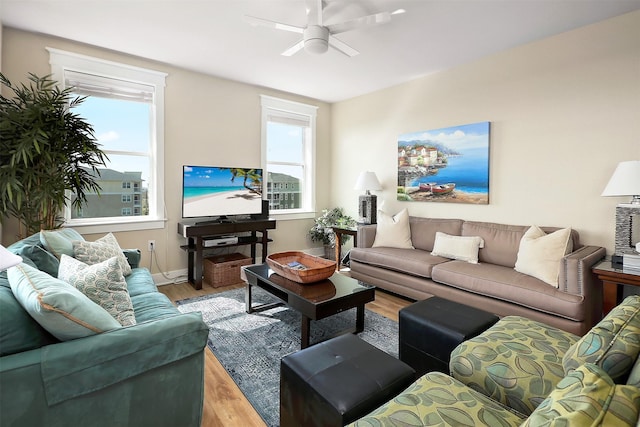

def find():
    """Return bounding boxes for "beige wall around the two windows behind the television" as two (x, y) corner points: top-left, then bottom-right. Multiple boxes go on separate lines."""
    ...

(2, 27), (331, 272)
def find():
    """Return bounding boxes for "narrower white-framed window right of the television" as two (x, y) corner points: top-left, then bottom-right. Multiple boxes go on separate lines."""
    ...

(261, 95), (318, 218)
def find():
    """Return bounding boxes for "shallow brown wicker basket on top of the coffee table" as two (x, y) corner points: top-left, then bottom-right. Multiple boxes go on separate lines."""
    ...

(267, 251), (336, 283)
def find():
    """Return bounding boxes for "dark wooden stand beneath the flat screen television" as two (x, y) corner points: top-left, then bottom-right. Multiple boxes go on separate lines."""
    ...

(178, 219), (276, 289)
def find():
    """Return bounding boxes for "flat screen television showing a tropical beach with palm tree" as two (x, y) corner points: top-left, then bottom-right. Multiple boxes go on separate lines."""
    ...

(182, 165), (263, 219)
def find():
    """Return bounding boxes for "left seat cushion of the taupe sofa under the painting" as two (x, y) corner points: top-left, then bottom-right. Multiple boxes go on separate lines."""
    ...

(349, 247), (451, 278)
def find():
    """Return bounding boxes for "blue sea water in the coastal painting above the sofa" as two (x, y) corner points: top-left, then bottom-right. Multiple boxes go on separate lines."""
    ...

(413, 147), (489, 194)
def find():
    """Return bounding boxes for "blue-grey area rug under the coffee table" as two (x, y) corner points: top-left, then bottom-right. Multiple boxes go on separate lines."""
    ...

(176, 288), (398, 426)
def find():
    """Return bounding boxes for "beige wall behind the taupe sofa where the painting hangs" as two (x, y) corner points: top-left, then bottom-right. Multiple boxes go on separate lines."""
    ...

(331, 12), (640, 253)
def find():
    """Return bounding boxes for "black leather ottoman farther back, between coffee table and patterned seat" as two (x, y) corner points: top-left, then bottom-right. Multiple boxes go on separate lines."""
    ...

(399, 297), (499, 376)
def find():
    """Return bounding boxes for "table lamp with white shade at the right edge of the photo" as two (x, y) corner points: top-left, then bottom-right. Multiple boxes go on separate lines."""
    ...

(602, 160), (640, 262)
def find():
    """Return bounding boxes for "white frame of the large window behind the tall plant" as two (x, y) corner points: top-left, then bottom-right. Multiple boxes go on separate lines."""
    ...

(46, 47), (167, 233)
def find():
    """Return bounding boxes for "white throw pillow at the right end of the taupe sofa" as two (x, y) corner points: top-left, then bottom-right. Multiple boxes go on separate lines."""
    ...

(515, 225), (571, 288)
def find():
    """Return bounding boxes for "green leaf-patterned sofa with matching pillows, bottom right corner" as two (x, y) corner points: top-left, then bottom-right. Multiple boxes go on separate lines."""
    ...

(352, 296), (640, 427)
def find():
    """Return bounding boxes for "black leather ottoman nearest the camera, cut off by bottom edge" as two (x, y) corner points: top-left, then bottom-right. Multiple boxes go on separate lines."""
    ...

(280, 334), (415, 427)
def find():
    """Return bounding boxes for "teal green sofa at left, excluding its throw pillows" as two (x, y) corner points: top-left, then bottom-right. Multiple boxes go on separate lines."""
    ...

(0, 233), (208, 427)
